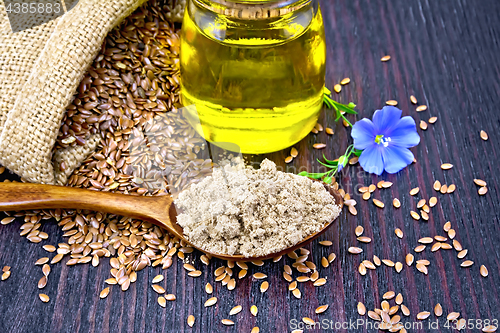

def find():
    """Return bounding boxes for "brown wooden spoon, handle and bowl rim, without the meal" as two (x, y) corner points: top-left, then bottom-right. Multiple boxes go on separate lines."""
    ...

(0, 183), (343, 261)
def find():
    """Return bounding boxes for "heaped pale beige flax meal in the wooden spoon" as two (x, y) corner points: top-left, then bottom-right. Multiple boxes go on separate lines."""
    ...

(175, 159), (340, 257)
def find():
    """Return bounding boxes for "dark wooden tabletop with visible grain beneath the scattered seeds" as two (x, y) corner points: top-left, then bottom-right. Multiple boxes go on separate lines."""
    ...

(0, 0), (500, 333)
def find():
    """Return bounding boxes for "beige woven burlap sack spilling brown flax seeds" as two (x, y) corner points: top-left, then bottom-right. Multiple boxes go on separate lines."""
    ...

(0, 0), (150, 184)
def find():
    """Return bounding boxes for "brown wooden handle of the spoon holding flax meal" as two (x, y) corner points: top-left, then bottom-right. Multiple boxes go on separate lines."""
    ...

(0, 183), (172, 221)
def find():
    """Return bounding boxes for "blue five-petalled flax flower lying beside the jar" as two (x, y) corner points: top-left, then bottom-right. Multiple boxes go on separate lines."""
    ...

(351, 106), (420, 175)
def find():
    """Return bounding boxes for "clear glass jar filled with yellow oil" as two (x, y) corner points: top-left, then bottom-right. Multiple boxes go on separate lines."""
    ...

(180, 0), (326, 154)
